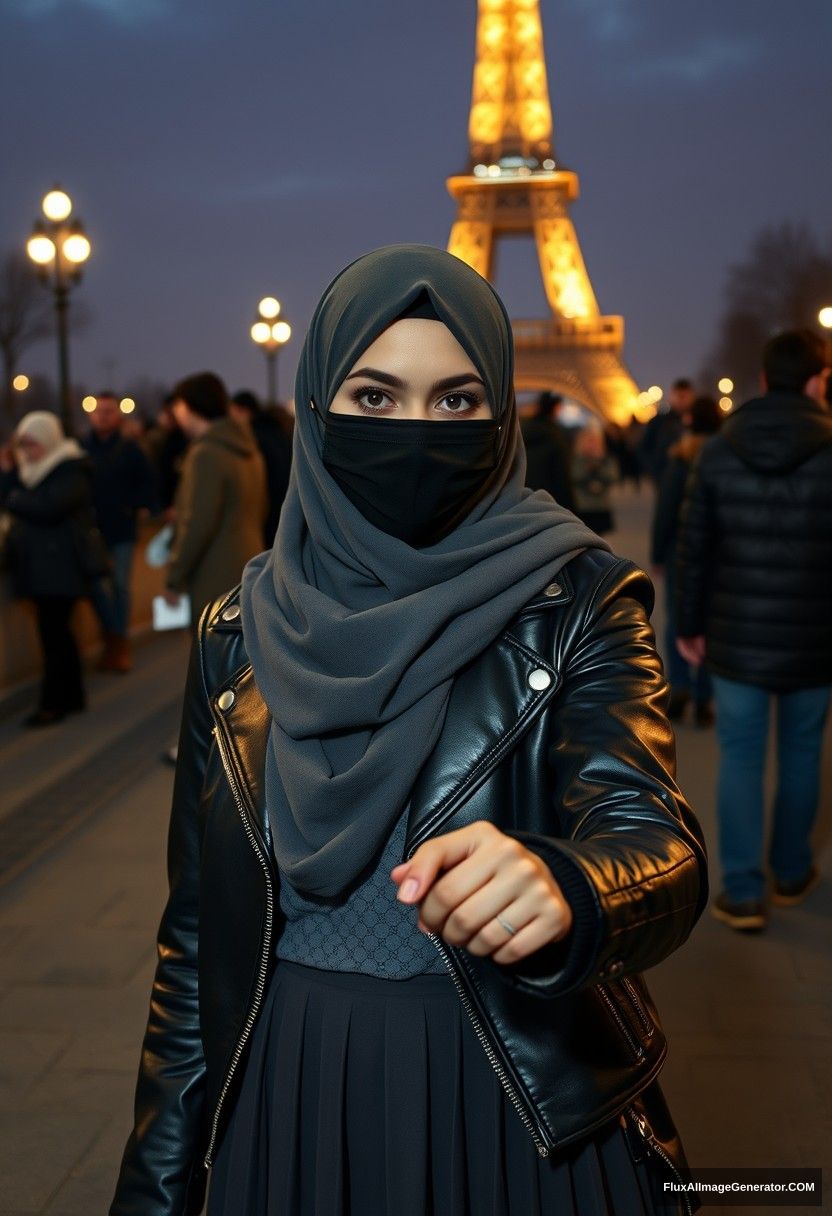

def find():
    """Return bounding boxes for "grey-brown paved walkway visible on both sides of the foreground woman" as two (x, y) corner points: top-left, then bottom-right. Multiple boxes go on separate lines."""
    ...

(0, 491), (832, 1216)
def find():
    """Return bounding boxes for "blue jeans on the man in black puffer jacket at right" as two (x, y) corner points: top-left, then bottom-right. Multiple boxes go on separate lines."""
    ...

(712, 676), (832, 900)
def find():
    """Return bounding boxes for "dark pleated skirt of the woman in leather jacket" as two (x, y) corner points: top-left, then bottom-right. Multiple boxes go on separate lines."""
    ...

(207, 959), (676, 1216)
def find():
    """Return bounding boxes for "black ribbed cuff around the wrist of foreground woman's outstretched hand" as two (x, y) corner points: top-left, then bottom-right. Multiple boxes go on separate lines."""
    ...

(493, 831), (606, 996)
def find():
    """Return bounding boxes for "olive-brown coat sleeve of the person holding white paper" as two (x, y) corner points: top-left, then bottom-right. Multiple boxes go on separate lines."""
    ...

(165, 444), (225, 591)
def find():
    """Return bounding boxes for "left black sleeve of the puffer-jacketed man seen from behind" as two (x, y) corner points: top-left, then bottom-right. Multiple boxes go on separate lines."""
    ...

(676, 446), (716, 637)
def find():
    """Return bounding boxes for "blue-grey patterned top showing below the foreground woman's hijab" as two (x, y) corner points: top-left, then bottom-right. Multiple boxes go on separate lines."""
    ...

(275, 806), (448, 979)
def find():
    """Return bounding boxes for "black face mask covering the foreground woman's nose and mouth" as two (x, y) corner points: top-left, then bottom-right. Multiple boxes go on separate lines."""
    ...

(322, 413), (500, 548)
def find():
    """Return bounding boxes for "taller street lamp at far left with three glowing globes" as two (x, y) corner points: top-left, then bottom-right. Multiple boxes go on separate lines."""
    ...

(26, 186), (92, 435)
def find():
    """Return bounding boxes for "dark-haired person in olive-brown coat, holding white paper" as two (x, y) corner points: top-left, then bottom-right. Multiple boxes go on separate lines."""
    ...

(165, 372), (268, 627)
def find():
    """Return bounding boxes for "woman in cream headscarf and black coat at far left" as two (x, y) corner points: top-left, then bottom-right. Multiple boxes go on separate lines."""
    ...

(0, 410), (95, 726)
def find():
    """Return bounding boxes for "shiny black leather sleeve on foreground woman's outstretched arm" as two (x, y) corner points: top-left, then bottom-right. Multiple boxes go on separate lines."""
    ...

(507, 562), (708, 996)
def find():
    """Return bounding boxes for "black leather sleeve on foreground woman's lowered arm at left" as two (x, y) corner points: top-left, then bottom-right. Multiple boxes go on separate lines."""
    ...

(109, 609), (212, 1216)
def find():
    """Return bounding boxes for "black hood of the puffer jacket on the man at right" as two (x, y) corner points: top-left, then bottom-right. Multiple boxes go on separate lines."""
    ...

(721, 393), (832, 474)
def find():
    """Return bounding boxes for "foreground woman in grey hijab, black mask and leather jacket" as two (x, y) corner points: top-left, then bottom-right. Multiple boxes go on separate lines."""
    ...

(111, 246), (707, 1216)
